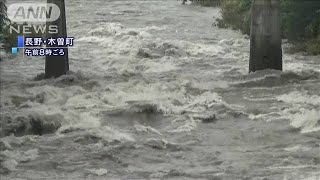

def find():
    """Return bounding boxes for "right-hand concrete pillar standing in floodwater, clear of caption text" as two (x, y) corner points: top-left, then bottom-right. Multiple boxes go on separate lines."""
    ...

(249, 0), (282, 72)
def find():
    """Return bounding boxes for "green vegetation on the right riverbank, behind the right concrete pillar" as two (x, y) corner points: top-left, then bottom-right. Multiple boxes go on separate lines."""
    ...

(195, 0), (320, 55)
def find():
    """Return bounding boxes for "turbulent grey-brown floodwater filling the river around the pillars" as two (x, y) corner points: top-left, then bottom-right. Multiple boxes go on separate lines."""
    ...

(0, 0), (320, 180)
